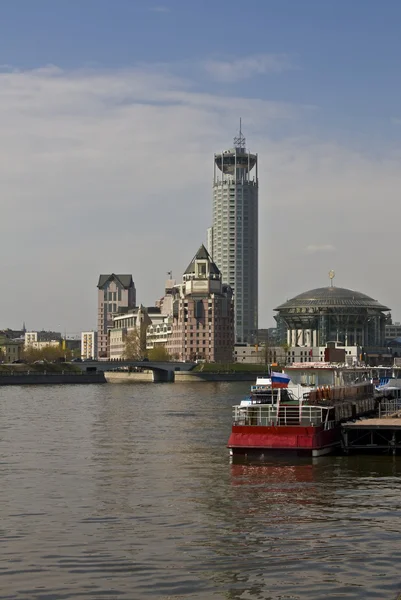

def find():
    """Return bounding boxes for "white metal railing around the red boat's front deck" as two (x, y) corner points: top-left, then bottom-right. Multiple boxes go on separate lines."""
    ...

(233, 404), (328, 429)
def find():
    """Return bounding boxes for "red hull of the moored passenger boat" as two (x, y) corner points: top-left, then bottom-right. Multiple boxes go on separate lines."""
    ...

(227, 425), (341, 456)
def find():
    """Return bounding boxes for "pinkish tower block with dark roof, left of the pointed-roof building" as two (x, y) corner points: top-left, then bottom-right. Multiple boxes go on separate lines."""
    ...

(97, 273), (136, 359)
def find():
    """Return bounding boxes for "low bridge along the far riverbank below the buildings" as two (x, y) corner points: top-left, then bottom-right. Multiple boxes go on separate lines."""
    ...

(74, 360), (196, 382)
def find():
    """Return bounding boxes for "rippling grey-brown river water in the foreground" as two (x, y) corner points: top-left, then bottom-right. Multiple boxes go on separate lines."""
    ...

(0, 383), (401, 600)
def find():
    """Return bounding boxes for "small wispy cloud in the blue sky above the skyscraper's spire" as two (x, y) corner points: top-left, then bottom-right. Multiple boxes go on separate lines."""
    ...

(204, 54), (294, 83)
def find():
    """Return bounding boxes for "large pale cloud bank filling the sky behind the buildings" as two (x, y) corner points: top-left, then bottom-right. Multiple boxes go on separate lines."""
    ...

(0, 66), (401, 331)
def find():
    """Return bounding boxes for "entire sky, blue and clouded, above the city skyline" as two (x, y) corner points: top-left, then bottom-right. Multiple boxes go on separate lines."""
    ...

(0, 0), (401, 333)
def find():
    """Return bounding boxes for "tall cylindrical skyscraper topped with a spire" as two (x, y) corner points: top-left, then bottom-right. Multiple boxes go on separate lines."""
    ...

(208, 124), (258, 343)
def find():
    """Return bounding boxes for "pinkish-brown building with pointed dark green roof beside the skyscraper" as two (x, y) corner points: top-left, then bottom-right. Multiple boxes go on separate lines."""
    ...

(167, 245), (234, 363)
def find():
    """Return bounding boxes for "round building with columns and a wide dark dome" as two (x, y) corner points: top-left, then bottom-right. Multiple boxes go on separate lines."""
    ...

(274, 286), (390, 347)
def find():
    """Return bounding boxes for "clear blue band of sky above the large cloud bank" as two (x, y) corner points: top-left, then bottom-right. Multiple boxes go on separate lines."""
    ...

(0, 0), (401, 121)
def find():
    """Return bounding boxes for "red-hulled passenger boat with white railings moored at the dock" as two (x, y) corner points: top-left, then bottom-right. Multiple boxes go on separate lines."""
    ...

(227, 366), (376, 457)
